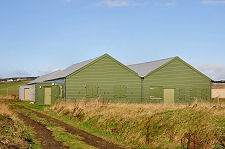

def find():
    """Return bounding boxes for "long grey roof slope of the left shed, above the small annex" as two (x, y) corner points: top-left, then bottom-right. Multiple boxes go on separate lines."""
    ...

(28, 57), (98, 84)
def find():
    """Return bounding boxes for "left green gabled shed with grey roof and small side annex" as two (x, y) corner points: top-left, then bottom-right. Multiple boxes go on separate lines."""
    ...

(35, 54), (141, 104)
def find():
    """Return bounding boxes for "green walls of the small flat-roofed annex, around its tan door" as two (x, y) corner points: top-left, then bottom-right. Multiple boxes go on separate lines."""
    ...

(35, 83), (63, 105)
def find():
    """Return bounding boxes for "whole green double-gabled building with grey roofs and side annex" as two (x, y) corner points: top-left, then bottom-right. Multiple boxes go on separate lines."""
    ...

(24, 54), (211, 104)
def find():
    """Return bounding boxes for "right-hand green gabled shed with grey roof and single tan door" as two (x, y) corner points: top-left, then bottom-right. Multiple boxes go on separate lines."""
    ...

(128, 57), (211, 103)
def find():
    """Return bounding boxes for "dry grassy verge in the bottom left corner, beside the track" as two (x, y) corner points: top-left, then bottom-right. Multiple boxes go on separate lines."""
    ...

(0, 102), (39, 149)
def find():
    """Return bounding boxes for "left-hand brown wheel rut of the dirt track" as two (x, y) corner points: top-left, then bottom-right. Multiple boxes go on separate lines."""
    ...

(17, 113), (68, 149)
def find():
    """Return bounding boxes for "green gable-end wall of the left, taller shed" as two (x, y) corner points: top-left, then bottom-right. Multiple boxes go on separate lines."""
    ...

(66, 56), (141, 102)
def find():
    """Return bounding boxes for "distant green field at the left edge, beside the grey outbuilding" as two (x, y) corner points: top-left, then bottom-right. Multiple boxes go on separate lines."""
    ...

(0, 82), (27, 96)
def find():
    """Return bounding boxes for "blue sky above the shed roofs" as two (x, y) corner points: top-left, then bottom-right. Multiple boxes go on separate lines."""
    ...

(0, 0), (225, 80)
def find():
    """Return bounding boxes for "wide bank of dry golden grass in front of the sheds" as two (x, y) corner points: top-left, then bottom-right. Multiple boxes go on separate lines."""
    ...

(46, 101), (225, 148)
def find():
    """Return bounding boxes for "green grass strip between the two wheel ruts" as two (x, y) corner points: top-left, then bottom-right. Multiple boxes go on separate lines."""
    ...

(12, 104), (95, 149)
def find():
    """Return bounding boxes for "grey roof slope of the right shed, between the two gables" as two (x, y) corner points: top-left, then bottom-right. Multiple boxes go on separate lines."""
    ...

(127, 57), (175, 77)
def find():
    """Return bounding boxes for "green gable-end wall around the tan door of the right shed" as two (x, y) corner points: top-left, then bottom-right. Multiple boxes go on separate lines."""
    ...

(143, 58), (211, 103)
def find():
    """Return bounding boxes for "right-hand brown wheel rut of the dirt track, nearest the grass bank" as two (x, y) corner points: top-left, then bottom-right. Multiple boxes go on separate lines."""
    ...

(15, 105), (123, 149)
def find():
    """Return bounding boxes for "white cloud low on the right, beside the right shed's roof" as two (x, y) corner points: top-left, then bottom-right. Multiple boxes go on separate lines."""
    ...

(198, 63), (225, 80)
